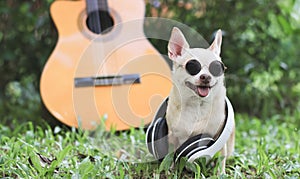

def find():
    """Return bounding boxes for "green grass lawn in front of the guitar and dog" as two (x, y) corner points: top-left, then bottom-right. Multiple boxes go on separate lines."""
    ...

(0, 114), (300, 178)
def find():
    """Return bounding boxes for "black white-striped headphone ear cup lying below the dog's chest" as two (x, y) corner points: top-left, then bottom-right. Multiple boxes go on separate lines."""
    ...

(174, 134), (215, 162)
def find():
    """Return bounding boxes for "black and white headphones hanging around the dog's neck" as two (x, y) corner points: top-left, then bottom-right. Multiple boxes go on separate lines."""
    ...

(146, 97), (234, 163)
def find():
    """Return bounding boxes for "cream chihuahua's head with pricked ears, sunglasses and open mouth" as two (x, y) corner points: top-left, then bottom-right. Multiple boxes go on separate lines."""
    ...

(168, 27), (226, 99)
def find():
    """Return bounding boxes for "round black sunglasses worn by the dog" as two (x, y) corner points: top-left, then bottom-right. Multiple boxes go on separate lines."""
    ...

(183, 59), (227, 77)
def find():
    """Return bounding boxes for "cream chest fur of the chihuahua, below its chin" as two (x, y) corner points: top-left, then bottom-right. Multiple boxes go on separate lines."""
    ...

(166, 85), (225, 148)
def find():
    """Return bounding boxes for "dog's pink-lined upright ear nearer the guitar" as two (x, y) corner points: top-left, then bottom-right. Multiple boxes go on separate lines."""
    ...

(168, 27), (189, 60)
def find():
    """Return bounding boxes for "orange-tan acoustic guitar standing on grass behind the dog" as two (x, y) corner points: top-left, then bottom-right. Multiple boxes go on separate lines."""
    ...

(40, 0), (172, 130)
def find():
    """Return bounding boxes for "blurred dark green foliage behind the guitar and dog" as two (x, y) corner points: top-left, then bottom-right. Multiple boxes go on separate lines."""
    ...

(0, 0), (300, 127)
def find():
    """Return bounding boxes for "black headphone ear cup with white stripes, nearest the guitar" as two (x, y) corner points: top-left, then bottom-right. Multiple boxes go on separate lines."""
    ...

(146, 118), (169, 160)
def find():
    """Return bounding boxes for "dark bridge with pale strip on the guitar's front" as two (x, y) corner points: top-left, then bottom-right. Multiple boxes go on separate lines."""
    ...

(74, 74), (141, 87)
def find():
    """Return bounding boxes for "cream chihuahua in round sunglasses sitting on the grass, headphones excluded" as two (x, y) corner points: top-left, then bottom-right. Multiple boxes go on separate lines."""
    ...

(166, 27), (235, 173)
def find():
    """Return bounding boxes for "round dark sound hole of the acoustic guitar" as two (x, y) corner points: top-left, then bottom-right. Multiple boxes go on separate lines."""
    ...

(86, 10), (114, 34)
